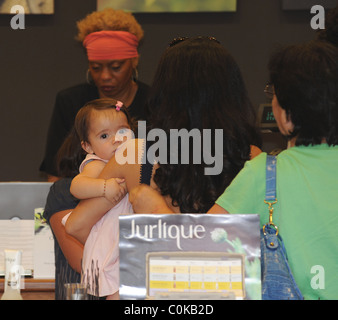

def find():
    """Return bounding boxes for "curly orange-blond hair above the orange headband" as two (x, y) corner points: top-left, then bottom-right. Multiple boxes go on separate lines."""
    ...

(76, 8), (144, 43)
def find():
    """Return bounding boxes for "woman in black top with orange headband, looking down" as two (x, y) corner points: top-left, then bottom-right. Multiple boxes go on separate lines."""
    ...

(40, 9), (149, 181)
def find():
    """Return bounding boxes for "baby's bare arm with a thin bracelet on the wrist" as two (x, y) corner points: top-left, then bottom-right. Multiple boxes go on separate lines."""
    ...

(70, 160), (126, 201)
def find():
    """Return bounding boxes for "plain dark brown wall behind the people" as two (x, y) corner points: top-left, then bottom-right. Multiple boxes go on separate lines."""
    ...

(0, 0), (320, 181)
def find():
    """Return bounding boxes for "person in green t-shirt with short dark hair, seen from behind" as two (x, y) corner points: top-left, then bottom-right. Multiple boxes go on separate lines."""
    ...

(209, 41), (338, 299)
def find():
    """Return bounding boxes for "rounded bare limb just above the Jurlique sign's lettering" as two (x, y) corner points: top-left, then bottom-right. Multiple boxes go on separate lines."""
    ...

(129, 184), (173, 214)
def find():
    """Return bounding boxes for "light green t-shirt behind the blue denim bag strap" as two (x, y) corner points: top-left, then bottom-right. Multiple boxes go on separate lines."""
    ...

(216, 144), (338, 299)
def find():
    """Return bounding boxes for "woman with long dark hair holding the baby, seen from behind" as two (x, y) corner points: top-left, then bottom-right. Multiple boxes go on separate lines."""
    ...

(66, 37), (260, 242)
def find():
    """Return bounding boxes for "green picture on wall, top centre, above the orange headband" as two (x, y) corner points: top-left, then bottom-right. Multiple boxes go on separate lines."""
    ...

(97, 0), (237, 13)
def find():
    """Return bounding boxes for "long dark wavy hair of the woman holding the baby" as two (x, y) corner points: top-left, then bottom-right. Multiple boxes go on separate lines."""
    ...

(148, 37), (261, 213)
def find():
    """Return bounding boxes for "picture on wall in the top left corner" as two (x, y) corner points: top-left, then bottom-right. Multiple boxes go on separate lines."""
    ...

(0, 0), (54, 14)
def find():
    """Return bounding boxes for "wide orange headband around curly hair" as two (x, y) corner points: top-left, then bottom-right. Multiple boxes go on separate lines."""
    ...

(83, 31), (138, 61)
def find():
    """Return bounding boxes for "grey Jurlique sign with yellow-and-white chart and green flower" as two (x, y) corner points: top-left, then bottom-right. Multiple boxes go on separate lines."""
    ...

(119, 214), (261, 300)
